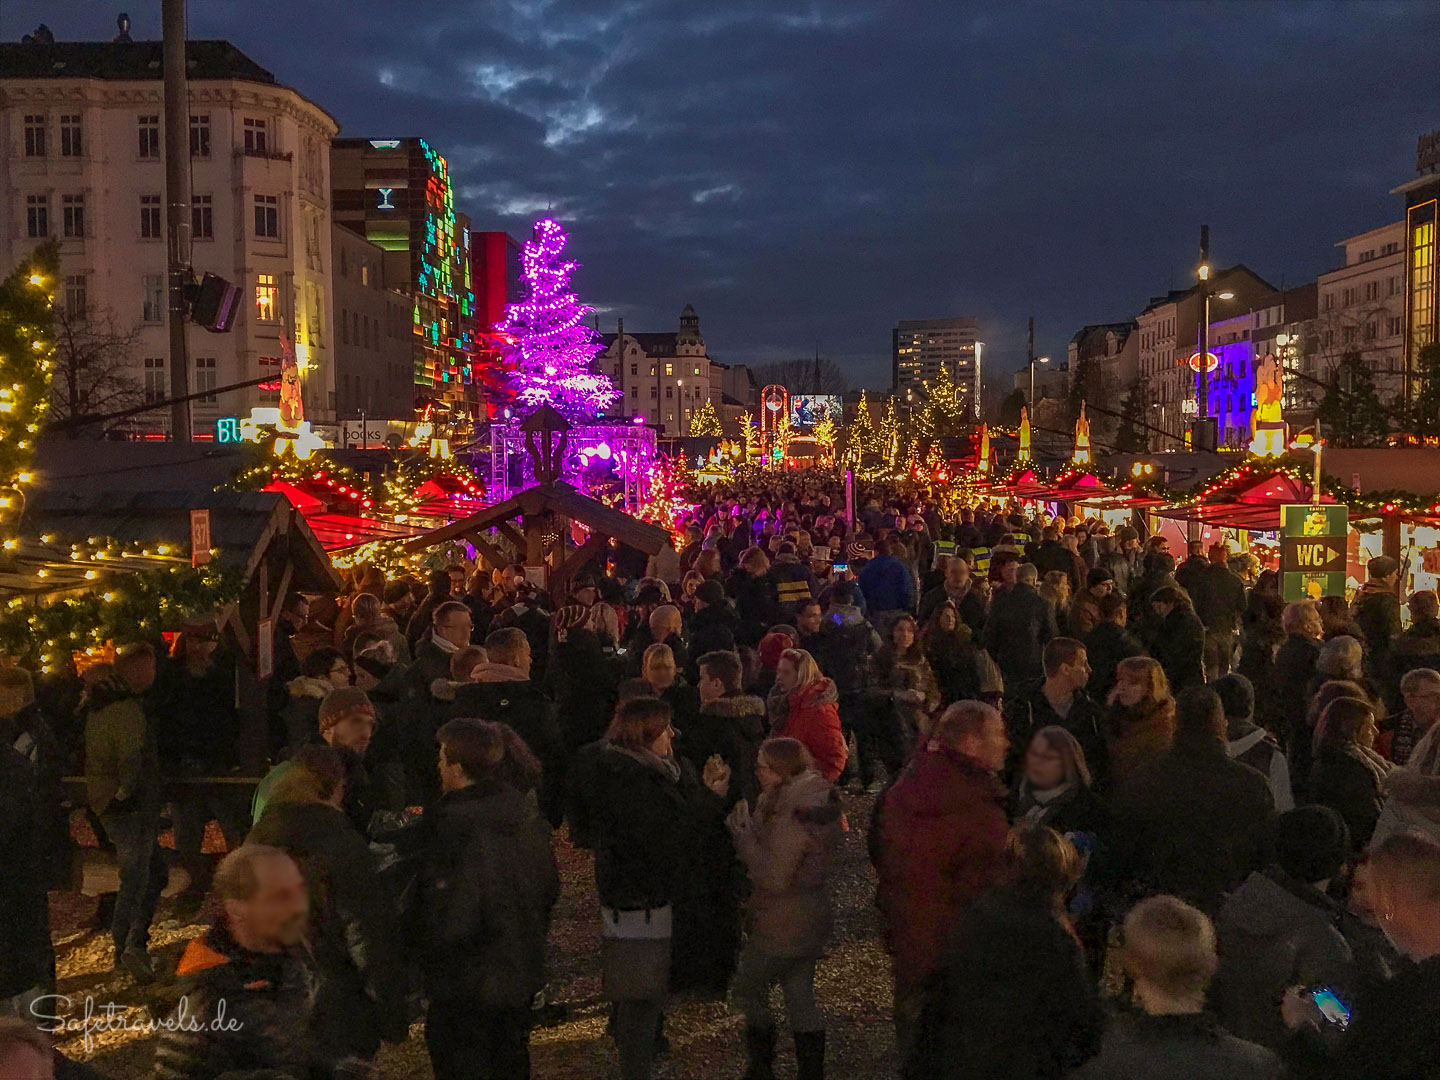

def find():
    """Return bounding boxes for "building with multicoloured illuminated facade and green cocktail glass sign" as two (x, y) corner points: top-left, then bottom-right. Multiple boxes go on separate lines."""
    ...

(330, 138), (478, 419)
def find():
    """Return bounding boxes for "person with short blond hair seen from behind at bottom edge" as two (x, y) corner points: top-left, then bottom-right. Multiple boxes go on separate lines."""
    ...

(1071, 896), (1284, 1080)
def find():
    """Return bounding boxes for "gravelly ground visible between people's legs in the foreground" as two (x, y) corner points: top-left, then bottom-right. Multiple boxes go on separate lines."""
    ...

(55, 798), (896, 1080)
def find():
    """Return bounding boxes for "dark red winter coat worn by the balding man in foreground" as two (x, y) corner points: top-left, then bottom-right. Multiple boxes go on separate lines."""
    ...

(870, 749), (1008, 994)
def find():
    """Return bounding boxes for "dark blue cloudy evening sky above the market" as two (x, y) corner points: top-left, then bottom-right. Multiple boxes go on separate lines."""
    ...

(8, 0), (1440, 387)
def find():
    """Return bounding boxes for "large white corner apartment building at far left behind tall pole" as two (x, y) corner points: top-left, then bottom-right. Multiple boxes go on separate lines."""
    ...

(0, 37), (338, 436)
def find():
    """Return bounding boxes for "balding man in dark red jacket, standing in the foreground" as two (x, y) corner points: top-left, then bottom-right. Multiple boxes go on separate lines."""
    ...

(870, 701), (1009, 1061)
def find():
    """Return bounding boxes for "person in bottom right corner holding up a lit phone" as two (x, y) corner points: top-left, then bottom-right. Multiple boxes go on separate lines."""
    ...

(1280, 832), (1440, 1080)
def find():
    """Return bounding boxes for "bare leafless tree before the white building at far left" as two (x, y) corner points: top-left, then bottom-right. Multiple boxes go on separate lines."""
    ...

(50, 307), (145, 439)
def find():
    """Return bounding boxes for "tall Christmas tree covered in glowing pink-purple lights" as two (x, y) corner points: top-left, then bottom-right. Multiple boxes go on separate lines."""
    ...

(495, 217), (619, 420)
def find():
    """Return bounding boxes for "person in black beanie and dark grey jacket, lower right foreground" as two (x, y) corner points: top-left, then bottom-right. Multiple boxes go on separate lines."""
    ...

(1211, 806), (1355, 1048)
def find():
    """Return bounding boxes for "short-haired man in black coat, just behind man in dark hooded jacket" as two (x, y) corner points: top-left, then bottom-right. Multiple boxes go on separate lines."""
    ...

(444, 626), (567, 825)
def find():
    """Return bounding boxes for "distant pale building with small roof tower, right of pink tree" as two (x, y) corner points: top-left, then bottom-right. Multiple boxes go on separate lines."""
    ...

(595, 304), (721, 438)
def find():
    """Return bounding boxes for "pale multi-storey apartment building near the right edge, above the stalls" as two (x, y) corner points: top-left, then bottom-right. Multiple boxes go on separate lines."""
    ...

(1308, 222), (1405, 403)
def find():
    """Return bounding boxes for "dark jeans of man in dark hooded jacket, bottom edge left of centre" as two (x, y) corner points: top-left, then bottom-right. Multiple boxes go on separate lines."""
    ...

(425, 998), (530, 1080)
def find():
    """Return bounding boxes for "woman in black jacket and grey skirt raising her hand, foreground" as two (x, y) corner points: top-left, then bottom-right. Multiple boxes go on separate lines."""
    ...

(570, 697), (730, 1080)
